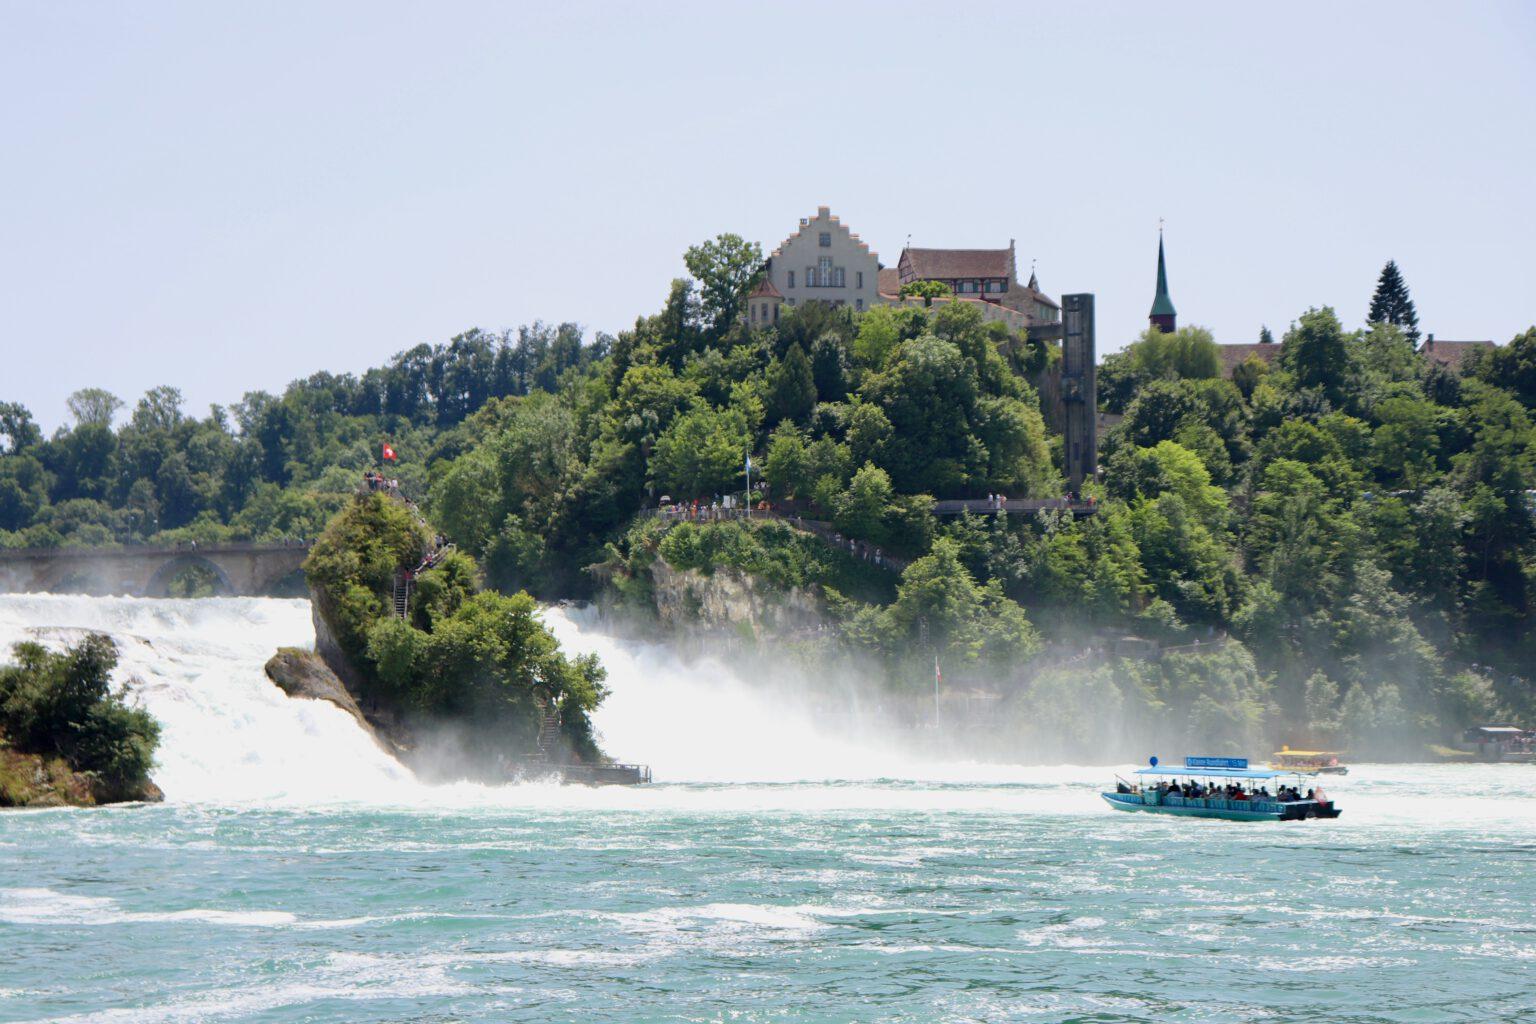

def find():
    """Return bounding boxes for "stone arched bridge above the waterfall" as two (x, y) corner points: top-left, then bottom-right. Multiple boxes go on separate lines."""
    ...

(0, 540), (309, 597)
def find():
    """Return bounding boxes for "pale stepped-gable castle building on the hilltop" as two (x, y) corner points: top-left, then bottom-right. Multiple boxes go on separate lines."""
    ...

(746, 206), (880, 325)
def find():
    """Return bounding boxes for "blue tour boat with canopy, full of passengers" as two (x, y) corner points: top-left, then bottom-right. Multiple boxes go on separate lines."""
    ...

(1100, 757), (1341, 821)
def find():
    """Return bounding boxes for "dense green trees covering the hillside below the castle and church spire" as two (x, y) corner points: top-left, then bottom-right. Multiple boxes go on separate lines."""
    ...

(0, 235), (1536, 751)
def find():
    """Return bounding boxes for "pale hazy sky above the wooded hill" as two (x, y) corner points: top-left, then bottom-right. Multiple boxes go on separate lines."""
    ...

(0, 0), (1536, 428)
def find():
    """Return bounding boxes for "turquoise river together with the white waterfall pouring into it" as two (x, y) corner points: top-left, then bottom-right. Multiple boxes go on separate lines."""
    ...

(0, 597), (1536, 1024)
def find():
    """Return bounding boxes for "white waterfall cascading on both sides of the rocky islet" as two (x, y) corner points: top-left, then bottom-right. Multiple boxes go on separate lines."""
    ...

(0, 594), (1086, 806)
